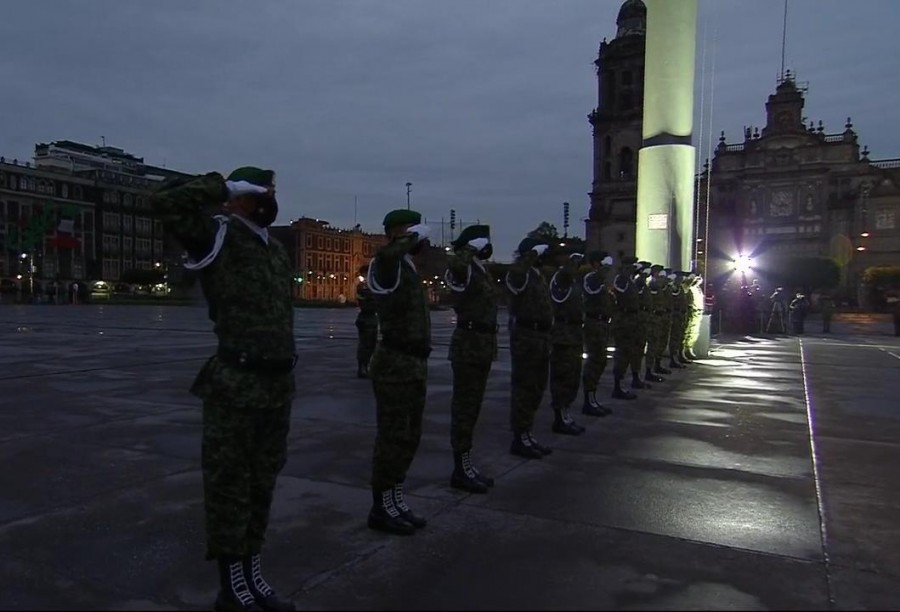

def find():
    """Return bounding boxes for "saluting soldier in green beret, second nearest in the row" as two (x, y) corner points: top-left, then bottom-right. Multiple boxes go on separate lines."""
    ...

(367, 209), (431, 535)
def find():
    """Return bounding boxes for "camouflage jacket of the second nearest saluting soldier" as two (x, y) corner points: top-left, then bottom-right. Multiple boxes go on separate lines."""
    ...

(368, 236), (431, 381)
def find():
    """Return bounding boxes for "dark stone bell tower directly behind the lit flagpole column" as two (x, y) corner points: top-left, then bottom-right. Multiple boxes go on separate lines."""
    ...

(585, 0), (647, 259)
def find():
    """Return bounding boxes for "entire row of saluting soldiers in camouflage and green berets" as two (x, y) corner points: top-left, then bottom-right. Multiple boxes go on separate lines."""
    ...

(151, 166), (712, 612)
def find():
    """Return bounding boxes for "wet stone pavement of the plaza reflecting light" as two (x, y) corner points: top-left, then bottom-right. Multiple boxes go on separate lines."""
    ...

(0, 306), (900, 610)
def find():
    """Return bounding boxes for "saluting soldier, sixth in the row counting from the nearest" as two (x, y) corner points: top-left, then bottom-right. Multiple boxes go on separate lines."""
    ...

(581, 251), (616, 417)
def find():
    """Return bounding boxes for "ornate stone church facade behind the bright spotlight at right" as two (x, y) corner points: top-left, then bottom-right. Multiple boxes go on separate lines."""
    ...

(698, 72), (900, 299)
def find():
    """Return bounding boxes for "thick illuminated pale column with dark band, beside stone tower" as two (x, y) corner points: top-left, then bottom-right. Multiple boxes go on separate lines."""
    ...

(636, 0), (697, 270)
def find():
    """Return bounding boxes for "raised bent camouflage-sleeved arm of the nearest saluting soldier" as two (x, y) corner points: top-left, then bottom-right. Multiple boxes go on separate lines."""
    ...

(150, 172), (228, 260)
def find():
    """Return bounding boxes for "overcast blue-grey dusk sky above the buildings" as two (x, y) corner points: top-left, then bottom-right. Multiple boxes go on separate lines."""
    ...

(0, 0), (900, 259)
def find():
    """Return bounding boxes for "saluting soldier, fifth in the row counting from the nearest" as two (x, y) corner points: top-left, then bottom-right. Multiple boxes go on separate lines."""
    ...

(550, 252), (585, 436)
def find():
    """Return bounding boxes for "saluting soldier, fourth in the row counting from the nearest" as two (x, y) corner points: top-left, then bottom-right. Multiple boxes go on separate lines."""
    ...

(506, 238), (553, 459)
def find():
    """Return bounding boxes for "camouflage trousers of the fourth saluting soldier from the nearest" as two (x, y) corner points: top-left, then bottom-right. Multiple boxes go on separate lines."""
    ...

(509, 328), (550, 434)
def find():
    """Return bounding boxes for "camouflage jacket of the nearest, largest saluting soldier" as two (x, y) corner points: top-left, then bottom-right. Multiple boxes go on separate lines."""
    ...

(151, 173), (295, 401)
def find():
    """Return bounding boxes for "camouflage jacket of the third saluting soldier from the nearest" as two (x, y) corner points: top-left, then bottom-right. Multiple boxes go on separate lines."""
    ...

(444, 248), (497, 363)
